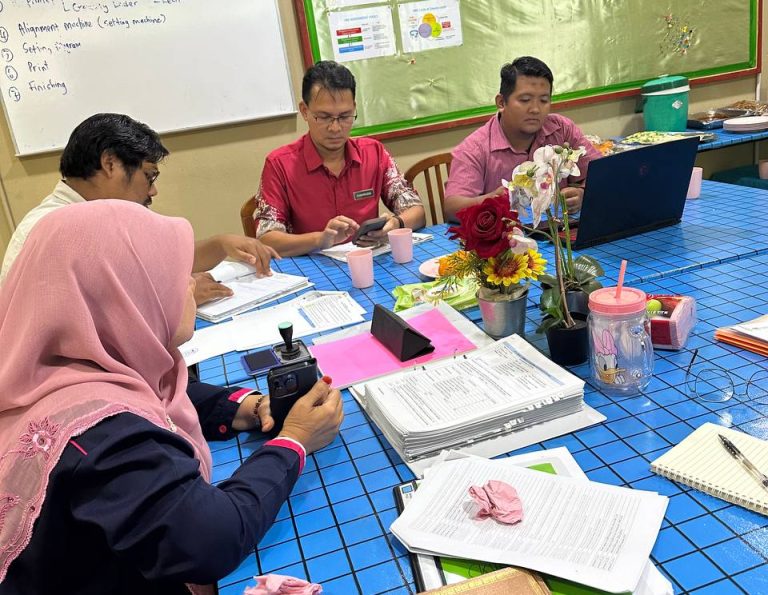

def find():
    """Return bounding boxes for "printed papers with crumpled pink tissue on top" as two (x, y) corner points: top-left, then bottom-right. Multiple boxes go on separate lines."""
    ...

(391, 453), (671, 593)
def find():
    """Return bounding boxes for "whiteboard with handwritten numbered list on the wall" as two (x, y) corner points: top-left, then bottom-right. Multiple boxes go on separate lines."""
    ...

(0, 0), (296, 155)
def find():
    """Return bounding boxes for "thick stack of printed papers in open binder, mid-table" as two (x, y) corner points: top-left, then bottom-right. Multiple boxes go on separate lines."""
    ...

(353, 335), (592, 468)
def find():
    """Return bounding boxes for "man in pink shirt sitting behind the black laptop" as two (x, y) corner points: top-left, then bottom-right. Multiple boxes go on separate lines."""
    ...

(443, 56), (600, 220)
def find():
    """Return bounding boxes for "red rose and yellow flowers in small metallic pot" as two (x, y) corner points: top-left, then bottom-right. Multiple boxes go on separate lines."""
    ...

(439, 196), (546, 338)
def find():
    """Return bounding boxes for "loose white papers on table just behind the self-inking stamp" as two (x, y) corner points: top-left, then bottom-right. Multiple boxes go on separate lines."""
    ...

(184, 291), (365, 366)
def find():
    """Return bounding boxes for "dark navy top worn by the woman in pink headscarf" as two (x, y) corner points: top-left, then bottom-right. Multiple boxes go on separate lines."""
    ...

(0, 382), (299, 595)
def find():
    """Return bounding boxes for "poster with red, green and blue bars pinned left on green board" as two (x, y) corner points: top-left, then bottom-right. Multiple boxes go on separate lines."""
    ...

(328, 6), (396, 62)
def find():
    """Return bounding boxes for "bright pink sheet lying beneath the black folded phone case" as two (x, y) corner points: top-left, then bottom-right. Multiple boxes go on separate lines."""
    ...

(309, 309), (476, 388)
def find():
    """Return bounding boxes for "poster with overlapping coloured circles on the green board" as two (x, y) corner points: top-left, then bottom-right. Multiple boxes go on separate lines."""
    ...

(397, 0), (462, 53)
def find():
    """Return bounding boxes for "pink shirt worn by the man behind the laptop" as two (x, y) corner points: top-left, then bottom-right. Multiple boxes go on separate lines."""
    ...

(445, 114), (601, 196)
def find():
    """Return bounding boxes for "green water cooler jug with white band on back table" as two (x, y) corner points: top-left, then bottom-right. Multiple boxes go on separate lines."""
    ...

(641, 76), (690, 132)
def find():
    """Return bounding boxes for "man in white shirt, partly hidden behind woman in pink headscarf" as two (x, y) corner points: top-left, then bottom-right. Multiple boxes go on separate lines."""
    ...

(0, 114), (277, 305)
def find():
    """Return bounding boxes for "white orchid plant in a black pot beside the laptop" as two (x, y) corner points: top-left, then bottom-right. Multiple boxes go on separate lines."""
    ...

(507, 143), (603, 365)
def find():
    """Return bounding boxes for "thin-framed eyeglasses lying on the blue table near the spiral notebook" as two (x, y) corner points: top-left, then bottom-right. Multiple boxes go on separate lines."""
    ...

(685, 349), (768, 405)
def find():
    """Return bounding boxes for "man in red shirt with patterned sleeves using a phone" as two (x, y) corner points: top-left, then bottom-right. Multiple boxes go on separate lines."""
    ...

(254, 61), (425, 256)
